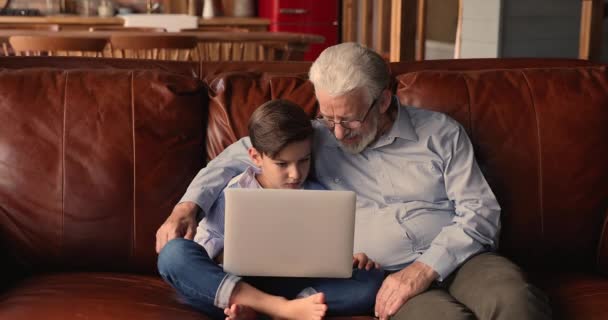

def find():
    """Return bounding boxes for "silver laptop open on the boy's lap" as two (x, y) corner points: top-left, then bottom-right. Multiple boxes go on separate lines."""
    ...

(224, 189), (356, 278)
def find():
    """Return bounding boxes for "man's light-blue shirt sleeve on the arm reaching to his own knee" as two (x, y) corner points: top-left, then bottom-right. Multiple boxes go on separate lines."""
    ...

(417, 125), (500, 281)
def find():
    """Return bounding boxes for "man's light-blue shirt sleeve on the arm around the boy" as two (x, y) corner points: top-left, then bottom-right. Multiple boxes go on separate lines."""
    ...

(179, 137), (252, 213)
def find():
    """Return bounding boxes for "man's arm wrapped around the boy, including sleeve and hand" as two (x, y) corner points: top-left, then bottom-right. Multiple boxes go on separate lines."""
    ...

(156, 137), (251, 253)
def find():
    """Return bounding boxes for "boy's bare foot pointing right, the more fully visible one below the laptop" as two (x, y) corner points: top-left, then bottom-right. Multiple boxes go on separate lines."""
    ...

(276, 293), (327, 320)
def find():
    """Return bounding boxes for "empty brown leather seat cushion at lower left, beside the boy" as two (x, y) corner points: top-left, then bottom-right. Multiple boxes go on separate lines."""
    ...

(0, 273), (207, 320)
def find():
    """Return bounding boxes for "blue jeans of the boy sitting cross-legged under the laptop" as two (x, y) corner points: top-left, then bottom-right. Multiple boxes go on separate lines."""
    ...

(158, 238), (384, 319)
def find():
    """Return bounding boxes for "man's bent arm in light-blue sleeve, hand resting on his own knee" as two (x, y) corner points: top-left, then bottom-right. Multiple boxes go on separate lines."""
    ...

(375, 125), (500, 319)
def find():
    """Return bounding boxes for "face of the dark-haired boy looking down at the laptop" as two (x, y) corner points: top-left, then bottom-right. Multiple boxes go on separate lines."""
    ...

(249, 139), (312, 189)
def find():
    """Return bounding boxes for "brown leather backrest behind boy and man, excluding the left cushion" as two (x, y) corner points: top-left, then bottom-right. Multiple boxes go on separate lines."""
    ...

(203, 59), (608, 269)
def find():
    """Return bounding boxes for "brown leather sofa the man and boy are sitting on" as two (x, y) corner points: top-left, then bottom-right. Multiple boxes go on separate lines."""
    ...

(0, 58), (608, 320)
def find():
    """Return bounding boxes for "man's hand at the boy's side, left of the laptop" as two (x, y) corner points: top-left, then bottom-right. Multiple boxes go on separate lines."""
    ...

(156, 202), (198, 253)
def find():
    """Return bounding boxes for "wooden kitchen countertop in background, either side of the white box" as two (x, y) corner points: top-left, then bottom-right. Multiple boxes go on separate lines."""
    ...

(0, 15), (270, 26)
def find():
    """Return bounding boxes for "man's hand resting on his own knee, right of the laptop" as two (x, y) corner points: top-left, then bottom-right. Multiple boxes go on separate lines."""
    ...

(375, 261), (439, 320)
